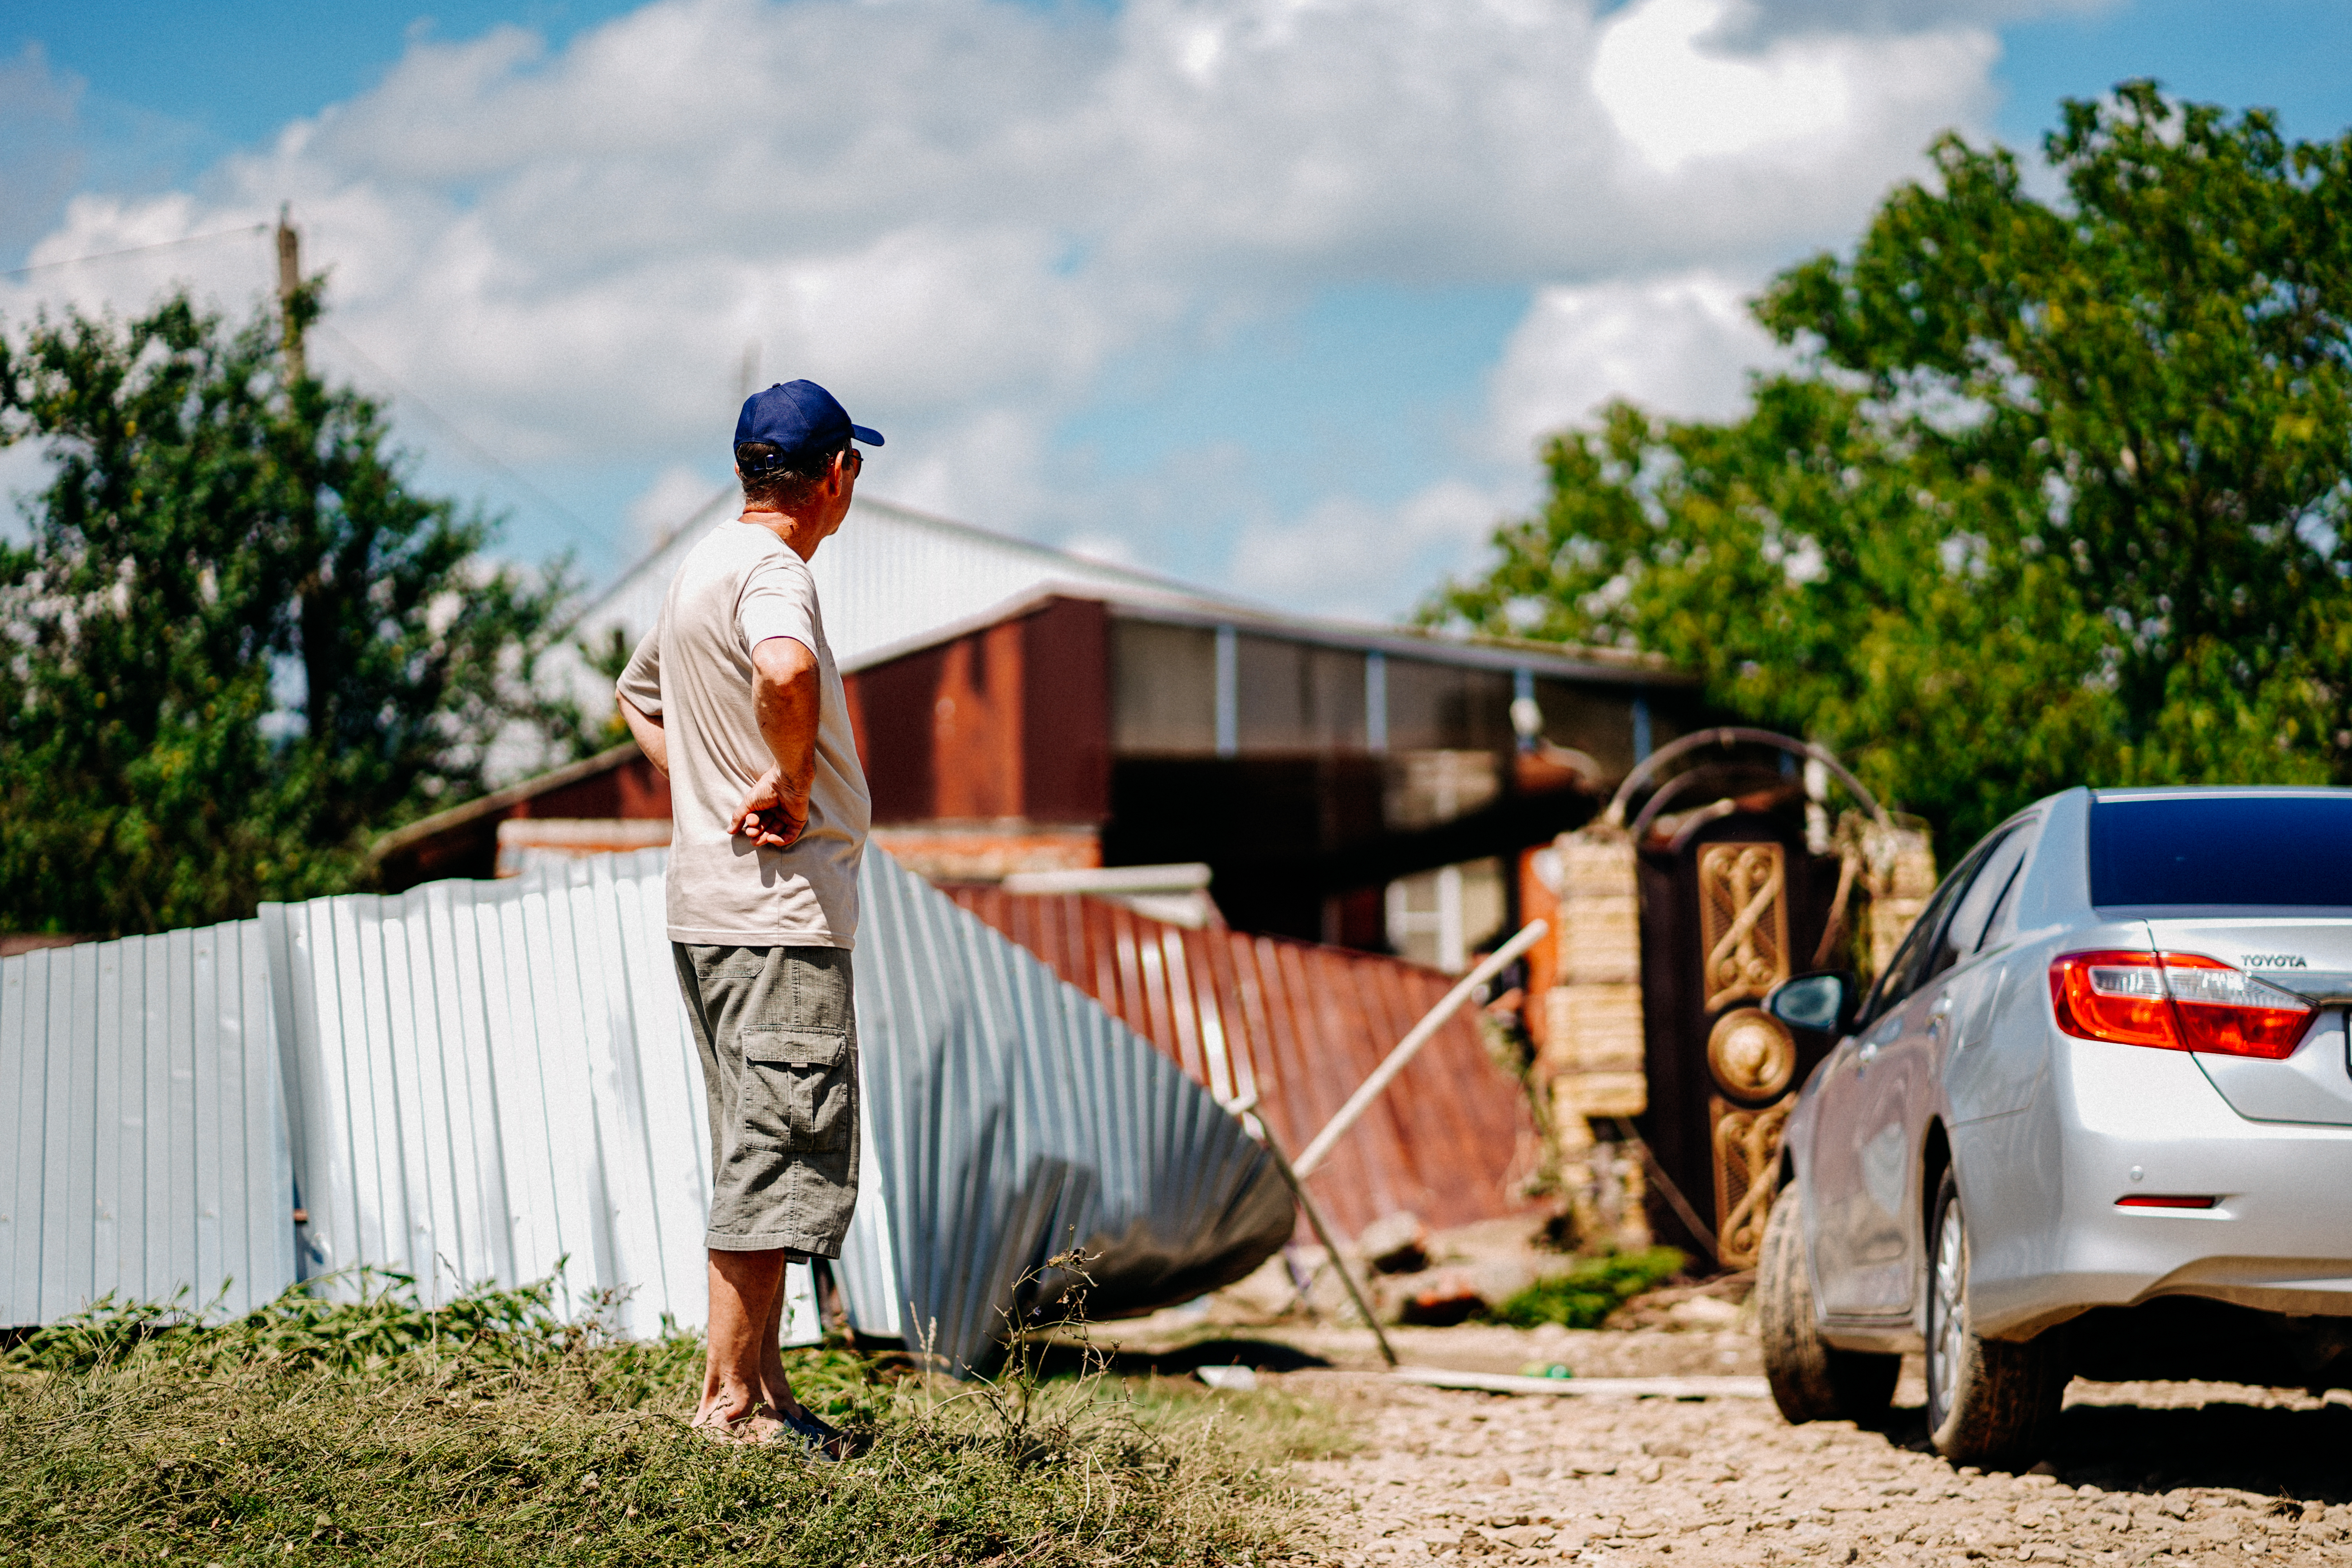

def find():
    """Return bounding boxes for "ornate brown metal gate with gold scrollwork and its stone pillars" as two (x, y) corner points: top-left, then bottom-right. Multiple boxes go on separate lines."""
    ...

(1538, 729), (1933, 1269)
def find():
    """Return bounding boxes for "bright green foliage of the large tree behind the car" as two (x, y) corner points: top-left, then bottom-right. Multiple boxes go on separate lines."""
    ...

(1423, 82), (2352, 853)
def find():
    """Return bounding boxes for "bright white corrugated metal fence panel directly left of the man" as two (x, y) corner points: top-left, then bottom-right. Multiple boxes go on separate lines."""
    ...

(261, 851), (818, 1342)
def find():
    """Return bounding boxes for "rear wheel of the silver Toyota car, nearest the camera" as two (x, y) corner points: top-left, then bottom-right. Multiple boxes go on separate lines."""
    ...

(1926, 1171), (2067, 1469)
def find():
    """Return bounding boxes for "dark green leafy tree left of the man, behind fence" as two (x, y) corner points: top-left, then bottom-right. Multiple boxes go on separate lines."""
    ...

(0, 289), (579, 933)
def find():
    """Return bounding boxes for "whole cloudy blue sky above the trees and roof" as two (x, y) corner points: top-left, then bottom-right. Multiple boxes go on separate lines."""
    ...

(0, 0), (2352, 618)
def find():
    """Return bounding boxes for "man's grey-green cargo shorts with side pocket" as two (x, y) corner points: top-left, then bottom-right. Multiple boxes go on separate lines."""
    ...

(670, 943), (858, 1258)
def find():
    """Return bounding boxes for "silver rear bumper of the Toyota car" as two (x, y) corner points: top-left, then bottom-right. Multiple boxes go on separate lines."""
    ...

(1952, 1037), (2352, 1338)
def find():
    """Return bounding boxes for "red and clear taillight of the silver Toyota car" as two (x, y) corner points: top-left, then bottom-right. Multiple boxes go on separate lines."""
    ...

(2051, 952), (2319, 1060)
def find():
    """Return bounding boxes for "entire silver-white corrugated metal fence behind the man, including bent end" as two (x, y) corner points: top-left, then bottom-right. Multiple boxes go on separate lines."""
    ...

(0, 849), (1291, 1366)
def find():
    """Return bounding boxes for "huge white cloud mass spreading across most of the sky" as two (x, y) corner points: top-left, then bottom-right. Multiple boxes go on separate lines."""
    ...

(0, 0), (2027, 595)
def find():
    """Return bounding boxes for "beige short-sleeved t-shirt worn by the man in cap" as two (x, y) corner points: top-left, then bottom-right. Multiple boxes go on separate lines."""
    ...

(619, 522), (873, 947)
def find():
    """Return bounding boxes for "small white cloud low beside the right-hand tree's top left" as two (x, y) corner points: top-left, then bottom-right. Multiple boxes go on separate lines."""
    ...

(1489, 273), (1788, 461)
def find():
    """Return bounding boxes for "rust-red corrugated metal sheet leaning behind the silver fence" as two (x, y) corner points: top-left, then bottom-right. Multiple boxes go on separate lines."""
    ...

(950, 889), (1538, 1234)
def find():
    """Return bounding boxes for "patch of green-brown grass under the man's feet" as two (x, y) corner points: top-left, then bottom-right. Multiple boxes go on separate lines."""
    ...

(0, 1276), (1334, 1568)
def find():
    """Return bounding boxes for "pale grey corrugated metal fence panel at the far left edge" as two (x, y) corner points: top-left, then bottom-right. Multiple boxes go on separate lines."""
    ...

(0, 922), (294, 1323)
